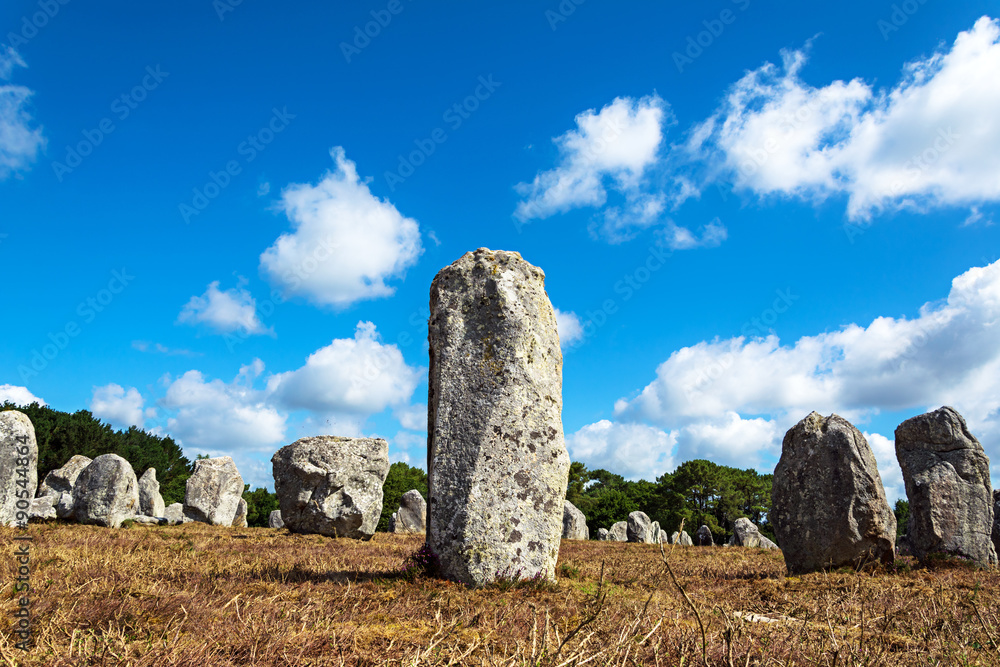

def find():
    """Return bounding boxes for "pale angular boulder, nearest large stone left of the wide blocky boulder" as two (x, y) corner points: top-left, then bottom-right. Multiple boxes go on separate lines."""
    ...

(184, 456), (243, 526)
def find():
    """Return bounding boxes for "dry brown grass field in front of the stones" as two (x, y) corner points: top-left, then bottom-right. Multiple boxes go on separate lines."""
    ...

(0, 524), (1000, 667)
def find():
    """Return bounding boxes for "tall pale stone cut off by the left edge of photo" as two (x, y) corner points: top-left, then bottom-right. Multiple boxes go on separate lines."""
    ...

(0, 410), (38, 526)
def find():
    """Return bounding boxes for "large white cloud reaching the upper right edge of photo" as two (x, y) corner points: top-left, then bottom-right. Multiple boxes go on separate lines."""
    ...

(686, 16), (1000, 220)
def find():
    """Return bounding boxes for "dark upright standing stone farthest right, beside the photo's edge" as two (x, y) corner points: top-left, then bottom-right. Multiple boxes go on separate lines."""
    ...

(896, 407), (997, 566)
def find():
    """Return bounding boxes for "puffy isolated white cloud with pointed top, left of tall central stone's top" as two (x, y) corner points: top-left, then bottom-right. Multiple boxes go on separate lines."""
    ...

(260, 146), (423, 308)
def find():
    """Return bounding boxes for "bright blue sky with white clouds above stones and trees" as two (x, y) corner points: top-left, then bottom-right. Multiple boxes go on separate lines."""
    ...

(0, 0), (1000, 496)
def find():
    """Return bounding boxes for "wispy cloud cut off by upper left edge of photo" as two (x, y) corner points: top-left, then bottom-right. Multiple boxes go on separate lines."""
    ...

(0, 46), (45, 180)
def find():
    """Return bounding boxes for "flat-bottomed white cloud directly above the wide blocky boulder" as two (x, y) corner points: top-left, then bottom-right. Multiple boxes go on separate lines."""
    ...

(268, 322), (423, 415)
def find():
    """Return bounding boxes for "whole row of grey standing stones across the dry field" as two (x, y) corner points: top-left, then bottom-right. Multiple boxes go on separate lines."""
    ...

(0, 248), (1000, 585)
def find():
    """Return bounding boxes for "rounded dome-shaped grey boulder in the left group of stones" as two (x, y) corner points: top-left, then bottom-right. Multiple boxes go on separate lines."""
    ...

(73, 454), (139, 528)
